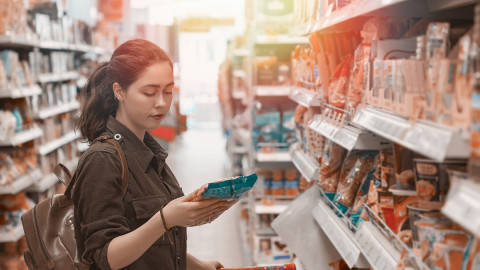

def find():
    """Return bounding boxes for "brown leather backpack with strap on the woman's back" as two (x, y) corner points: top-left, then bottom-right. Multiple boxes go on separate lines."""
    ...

(22, 136), (128, 270)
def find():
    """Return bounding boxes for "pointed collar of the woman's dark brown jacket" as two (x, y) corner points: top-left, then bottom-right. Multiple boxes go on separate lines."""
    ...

(107, 116), (168, 171)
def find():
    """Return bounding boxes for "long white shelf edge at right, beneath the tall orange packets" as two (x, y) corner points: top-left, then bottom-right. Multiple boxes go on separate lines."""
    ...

(353, 107), (470, 161)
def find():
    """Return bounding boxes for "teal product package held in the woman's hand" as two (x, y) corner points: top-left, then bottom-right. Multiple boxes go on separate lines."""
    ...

(197, 173), (257, 200)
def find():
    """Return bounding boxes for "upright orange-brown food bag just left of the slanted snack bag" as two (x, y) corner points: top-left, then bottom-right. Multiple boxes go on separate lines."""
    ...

(319, 140), (347, 200)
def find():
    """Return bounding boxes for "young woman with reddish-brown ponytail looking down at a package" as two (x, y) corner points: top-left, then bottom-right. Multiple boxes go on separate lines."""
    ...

(72, 40), (230, 270)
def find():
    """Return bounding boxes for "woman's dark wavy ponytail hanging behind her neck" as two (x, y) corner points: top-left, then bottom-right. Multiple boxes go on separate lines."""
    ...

(76, 62), (118, 143)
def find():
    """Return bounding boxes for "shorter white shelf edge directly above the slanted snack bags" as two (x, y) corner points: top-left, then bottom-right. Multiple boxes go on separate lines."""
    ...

(310, 115), (390, 150)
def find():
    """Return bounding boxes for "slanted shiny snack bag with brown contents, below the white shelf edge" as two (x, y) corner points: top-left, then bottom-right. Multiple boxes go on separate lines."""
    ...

(335, 151), (378, 213)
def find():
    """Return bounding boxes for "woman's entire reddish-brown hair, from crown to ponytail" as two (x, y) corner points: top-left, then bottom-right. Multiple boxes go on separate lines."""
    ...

(76, 39), (173, 143)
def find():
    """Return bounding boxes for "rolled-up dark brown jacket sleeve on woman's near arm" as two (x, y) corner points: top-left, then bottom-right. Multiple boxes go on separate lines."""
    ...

(72, 151), (130, 270)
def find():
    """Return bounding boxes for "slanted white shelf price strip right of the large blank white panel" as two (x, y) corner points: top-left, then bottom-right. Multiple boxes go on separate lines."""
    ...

(312, 201), (368, 268)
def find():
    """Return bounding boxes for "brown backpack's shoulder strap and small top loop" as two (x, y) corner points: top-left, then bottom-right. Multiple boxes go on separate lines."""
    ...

(65, 134), (128, 197)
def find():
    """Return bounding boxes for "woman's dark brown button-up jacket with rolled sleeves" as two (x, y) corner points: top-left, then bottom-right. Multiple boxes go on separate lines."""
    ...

(72, 117), (187, 270)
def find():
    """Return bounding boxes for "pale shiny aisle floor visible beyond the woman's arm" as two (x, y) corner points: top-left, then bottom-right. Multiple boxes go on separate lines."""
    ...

(167, 122), (244, 267)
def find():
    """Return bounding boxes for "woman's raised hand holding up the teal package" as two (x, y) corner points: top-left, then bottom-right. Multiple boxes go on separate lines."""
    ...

(163, 190), (230, 229)
